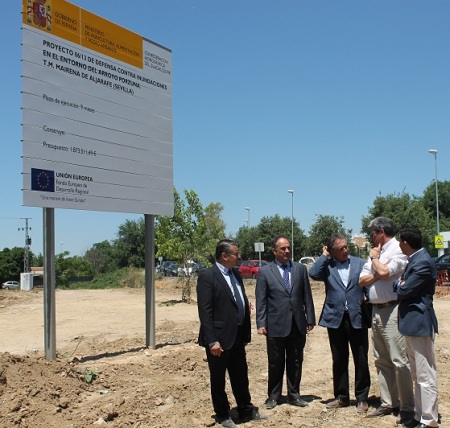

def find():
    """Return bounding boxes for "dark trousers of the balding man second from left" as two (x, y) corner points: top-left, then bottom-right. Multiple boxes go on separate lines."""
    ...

(267, 320), (306, 401)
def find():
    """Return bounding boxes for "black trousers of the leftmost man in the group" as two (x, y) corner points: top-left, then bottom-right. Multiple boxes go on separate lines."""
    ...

(206, 327), (253, 420)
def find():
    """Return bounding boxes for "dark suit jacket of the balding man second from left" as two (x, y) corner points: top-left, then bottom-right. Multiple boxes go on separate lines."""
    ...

(256, 262), (316, 337)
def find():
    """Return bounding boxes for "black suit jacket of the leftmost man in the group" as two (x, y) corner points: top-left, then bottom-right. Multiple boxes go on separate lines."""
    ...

(197, 264), (251, 350)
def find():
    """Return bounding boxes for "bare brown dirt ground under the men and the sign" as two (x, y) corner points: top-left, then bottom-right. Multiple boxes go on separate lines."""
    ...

(0, 279), (450, 428)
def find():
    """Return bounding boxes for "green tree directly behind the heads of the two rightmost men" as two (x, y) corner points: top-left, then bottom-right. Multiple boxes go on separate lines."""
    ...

(361, 193), (436, 255)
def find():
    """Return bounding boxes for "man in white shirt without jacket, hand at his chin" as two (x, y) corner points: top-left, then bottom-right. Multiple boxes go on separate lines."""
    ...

(359, 217), (414, 424)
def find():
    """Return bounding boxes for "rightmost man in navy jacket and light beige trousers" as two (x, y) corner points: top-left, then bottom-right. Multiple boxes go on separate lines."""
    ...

(394, 228), (438, 428)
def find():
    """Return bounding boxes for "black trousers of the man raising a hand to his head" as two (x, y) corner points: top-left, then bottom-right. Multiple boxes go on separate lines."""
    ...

(327, 313), (370, 401)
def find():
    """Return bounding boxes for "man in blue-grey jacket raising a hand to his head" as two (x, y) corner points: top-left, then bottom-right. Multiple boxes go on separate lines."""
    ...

(309, 233), (370, 413)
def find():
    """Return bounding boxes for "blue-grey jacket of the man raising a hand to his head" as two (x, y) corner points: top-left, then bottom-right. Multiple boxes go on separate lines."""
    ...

(309, 255), (369, 328)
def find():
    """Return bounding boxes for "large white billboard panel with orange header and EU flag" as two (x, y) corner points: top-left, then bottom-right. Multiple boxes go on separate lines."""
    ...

(22, 0), (173, 215)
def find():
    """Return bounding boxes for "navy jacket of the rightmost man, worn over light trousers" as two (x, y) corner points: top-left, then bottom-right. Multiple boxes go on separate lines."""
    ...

(394, 249), (438, 336)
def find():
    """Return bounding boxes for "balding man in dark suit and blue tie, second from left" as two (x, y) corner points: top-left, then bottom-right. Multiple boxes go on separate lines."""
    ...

(256, 235), (316, 409)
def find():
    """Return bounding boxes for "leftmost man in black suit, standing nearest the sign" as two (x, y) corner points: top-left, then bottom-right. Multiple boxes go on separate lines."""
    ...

(197, 239), (267, 428)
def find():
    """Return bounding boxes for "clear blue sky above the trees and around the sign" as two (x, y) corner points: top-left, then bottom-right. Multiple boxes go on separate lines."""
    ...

(0, 0), (450, 255)
